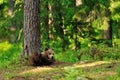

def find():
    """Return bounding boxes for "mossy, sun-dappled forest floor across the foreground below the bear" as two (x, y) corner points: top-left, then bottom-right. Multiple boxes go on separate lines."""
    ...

(0, 61), (120, 80)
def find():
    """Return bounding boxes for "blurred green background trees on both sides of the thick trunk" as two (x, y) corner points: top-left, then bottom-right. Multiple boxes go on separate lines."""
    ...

(0, 0), (120, 50)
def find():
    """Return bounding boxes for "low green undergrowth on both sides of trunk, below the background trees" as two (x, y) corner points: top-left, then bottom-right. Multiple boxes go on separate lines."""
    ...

(0, 41), (120, 68)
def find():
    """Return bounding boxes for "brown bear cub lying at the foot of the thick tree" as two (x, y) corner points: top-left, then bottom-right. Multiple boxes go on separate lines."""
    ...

(29, 48), (55, 66)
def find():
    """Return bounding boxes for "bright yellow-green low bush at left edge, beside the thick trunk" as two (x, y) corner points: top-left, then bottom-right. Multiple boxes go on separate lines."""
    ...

(0, 42), (21, 68)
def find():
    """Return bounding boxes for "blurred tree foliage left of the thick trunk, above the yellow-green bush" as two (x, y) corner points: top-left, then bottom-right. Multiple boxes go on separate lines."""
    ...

(0, 0), (23, 42)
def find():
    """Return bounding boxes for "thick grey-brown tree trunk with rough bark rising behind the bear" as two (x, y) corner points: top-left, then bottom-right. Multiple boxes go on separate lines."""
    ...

(23, 0), (41, 56)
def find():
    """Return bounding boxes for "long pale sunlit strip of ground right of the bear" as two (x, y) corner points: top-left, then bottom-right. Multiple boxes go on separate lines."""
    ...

(73, 61), (111, 68)
